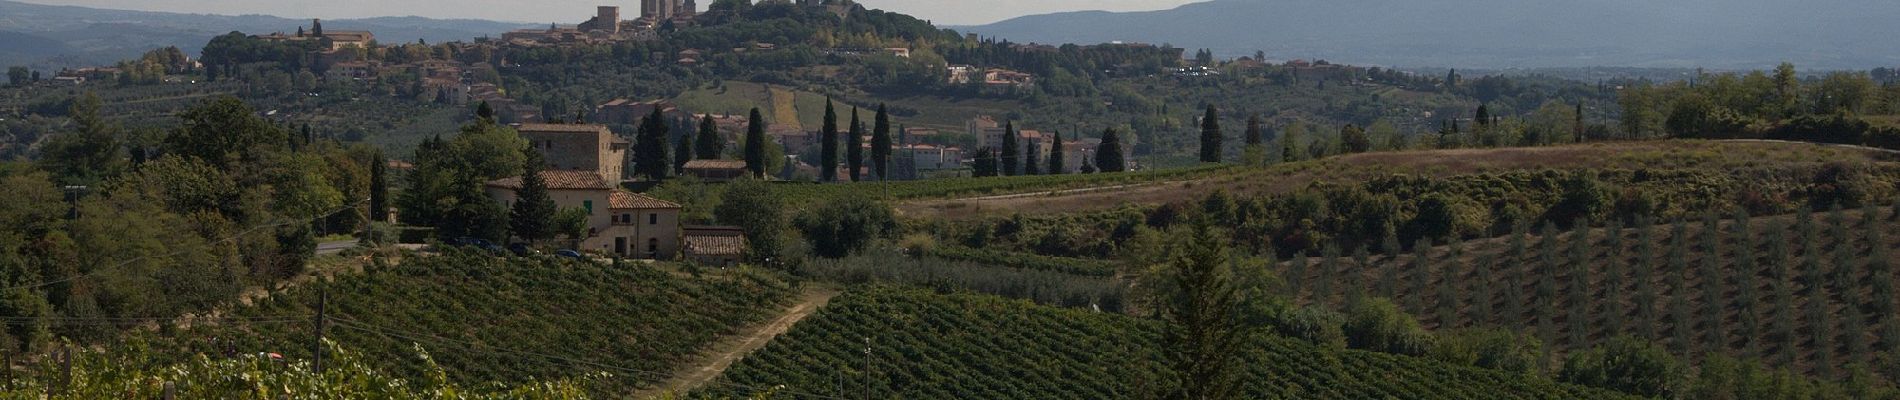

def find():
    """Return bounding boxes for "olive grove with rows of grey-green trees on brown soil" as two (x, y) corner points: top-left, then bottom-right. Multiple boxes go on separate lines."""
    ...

(1281, 207), (1900, 377)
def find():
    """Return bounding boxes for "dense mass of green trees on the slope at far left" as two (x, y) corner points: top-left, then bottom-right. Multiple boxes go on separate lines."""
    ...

(0, 95), (384, 351)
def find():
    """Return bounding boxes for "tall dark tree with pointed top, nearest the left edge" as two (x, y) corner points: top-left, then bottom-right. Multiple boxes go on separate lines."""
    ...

(40, 91), (125, 186)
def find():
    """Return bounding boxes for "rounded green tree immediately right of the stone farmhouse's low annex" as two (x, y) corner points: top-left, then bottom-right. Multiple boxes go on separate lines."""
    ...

(713, 180), (785, 264)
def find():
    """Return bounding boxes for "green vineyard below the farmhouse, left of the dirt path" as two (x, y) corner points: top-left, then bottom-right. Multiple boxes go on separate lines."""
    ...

(138, 254), (794, 391)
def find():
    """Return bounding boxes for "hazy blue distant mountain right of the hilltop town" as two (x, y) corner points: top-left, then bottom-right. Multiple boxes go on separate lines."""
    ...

(956, 0), (1900, 68)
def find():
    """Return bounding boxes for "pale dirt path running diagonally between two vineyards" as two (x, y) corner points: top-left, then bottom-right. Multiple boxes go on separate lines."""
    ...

(633, 286), (838, 398)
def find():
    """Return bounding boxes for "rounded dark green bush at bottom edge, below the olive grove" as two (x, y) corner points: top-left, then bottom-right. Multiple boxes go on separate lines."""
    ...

(1556, 337), (1683, 398)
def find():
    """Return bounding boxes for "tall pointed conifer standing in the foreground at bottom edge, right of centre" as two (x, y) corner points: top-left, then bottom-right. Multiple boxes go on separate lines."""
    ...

(1157, 222), (1248, 400)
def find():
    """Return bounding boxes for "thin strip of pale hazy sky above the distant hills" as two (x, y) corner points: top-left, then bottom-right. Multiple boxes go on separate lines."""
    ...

(25, 0), (1197, 25)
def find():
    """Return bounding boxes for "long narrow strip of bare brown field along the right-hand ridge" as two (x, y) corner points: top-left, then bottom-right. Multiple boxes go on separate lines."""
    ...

(899, 140), (1900, 220)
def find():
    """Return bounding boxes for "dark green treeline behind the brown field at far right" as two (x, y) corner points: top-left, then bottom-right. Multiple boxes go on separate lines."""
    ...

(1619, 63), (1900, 148)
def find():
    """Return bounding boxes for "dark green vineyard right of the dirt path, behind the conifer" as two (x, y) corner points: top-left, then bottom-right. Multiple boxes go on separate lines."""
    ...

(699, 288), (1623, 398)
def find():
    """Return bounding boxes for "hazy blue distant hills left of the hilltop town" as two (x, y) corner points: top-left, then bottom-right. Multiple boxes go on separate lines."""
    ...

(0, 0), (542, 70)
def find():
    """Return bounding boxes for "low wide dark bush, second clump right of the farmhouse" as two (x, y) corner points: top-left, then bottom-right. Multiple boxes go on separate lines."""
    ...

(792, 195), (897, 258)
